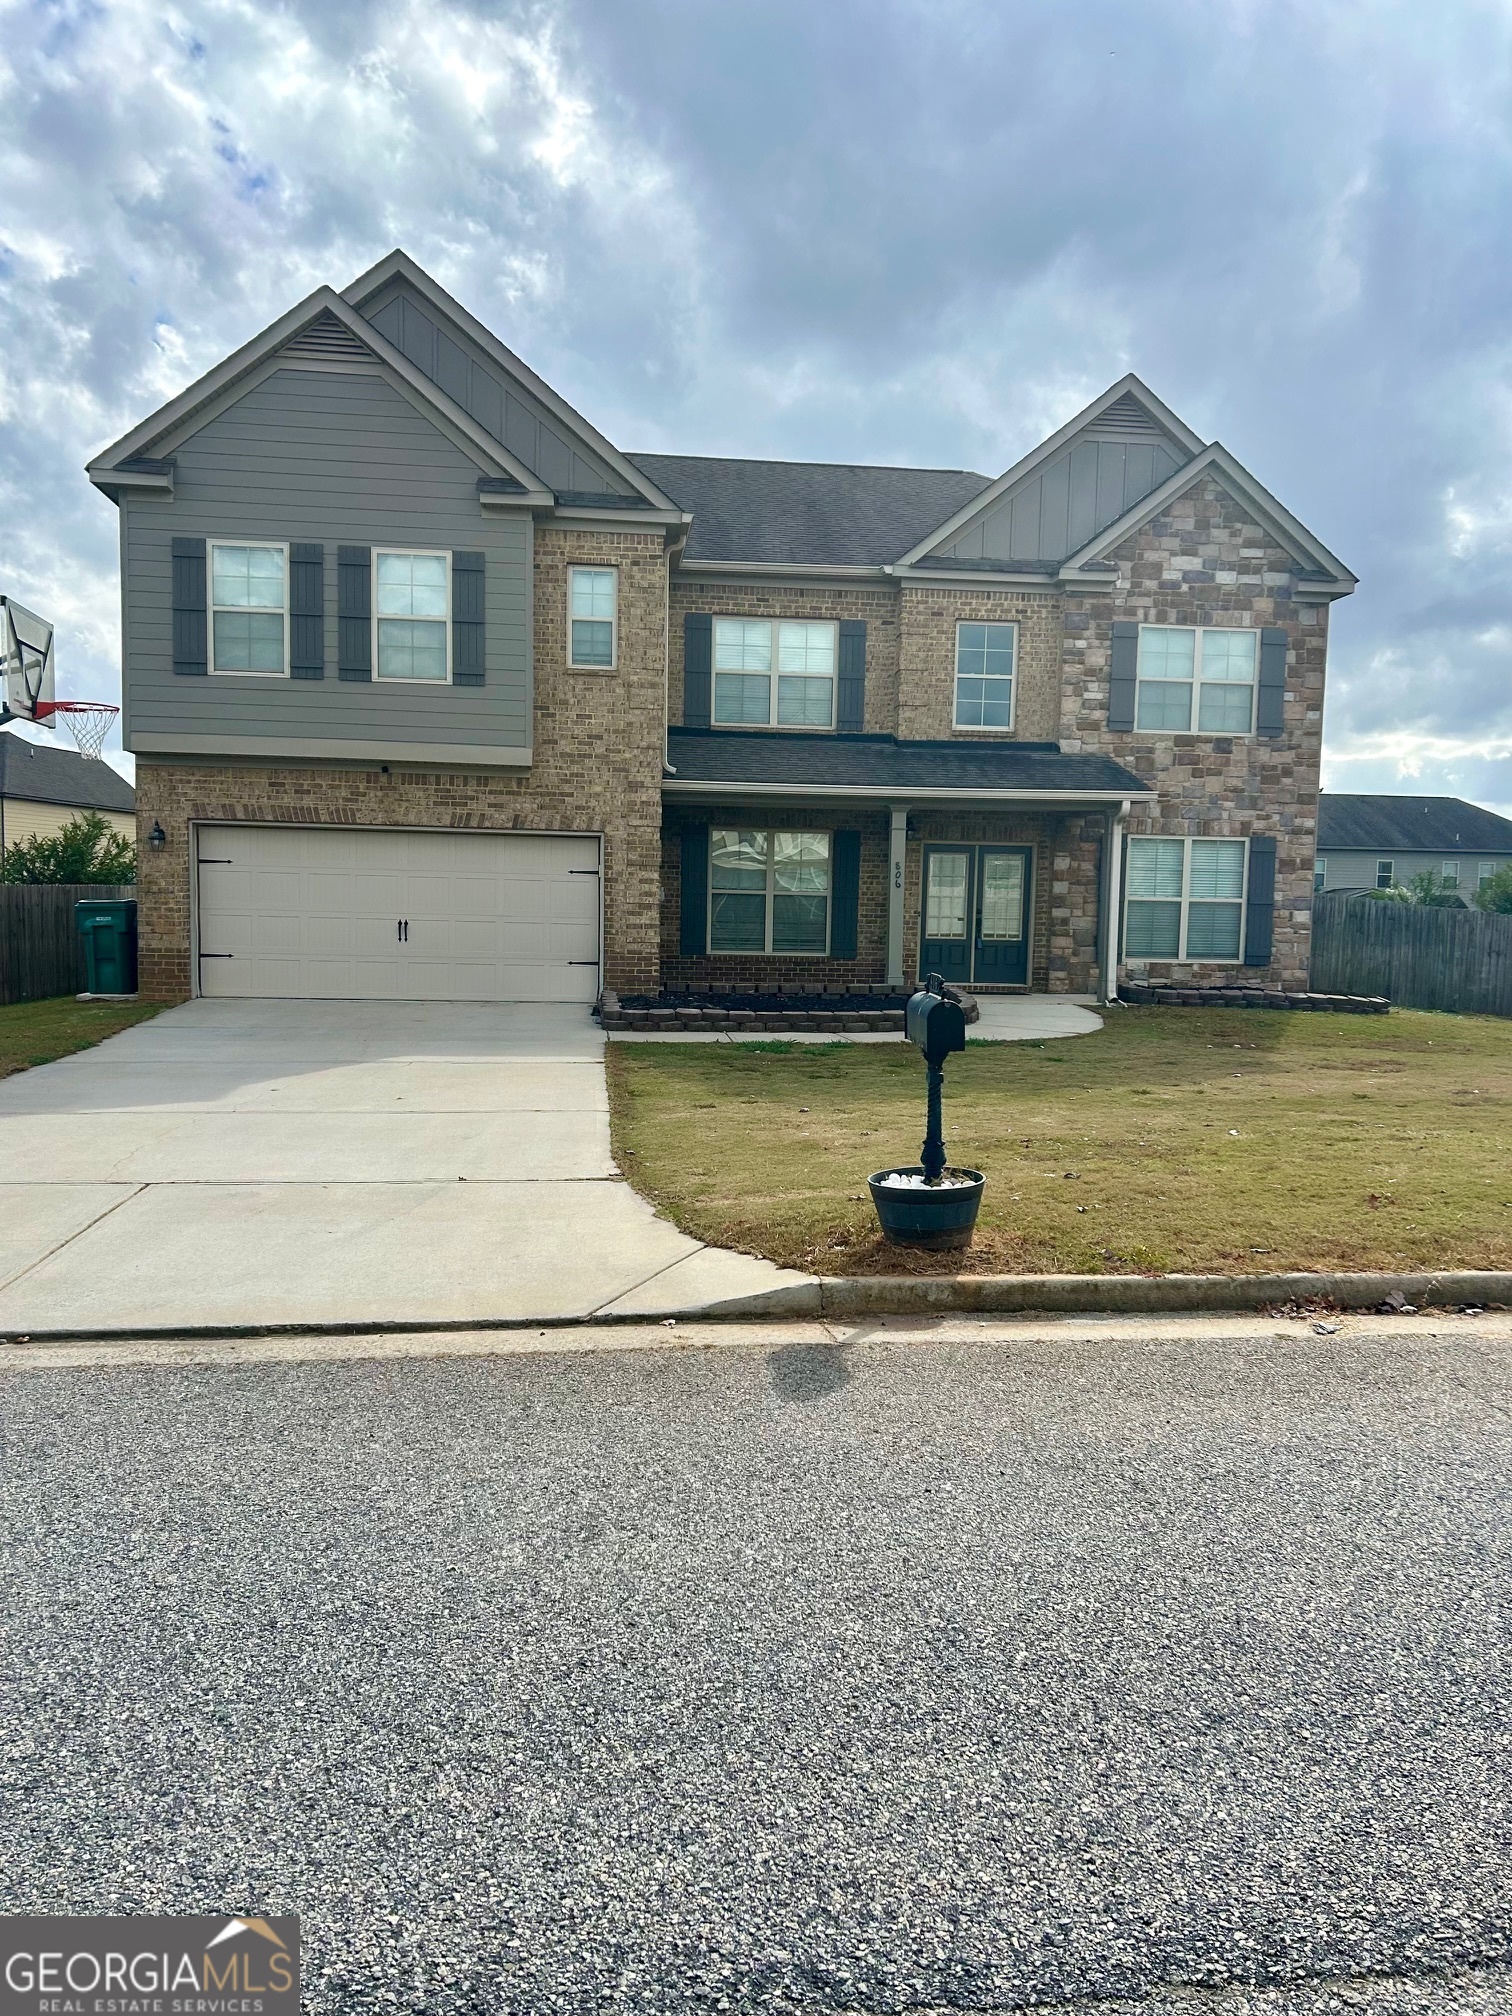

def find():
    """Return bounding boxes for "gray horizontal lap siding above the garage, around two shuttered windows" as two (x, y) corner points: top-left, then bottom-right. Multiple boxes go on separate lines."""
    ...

(121, 367), (532, 764)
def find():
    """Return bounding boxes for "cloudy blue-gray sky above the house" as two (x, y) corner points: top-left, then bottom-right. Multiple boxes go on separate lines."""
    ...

(0, 0), (1512, 810)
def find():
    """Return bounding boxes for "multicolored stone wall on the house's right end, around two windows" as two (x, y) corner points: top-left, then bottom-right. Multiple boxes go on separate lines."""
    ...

(1060, 478), (1329, 988)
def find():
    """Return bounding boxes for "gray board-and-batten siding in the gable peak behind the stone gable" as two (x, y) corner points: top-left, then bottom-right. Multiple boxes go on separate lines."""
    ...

(929, 393), (1189, 566)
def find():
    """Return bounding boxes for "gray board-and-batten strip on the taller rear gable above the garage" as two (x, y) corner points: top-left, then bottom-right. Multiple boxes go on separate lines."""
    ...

(363, 280), (639, 504)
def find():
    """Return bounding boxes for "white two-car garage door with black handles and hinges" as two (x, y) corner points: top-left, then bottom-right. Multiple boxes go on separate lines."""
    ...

(196, 827), (599, 1002)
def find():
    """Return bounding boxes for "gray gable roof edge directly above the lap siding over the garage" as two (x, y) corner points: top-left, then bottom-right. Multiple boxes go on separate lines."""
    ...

(87, 286), (552, 504)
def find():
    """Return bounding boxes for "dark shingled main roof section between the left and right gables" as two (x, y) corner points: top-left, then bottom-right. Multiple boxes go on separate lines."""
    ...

(631, 454), (988, 566)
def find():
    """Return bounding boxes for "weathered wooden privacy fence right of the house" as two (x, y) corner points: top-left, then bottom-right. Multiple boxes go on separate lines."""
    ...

(1310, 891), (1512, 1016)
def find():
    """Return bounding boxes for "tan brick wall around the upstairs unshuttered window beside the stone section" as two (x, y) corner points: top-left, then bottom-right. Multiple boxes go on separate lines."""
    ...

(897, 581), (1060, 742)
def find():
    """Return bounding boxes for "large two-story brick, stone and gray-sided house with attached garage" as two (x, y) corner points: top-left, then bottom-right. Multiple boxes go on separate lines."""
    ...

(89, 252), (1355, 1000)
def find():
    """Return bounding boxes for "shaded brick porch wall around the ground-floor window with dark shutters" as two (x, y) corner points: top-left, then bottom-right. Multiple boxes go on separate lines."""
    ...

(661, 802), (891, 994)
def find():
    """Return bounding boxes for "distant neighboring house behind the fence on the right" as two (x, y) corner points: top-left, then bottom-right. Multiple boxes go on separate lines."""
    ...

(1312, 790), (1512, 903)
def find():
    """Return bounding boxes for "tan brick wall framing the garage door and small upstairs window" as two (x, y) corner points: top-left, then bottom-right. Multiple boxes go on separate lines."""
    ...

(137, 526), (667, 1000)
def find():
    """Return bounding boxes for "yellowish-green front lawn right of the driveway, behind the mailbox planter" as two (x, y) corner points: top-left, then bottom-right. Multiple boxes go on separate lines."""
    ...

(609, 1008), (1512, 1274)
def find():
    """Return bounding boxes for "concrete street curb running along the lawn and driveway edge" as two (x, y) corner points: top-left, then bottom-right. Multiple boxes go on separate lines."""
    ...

(0, 1268), (1512, 1369)
